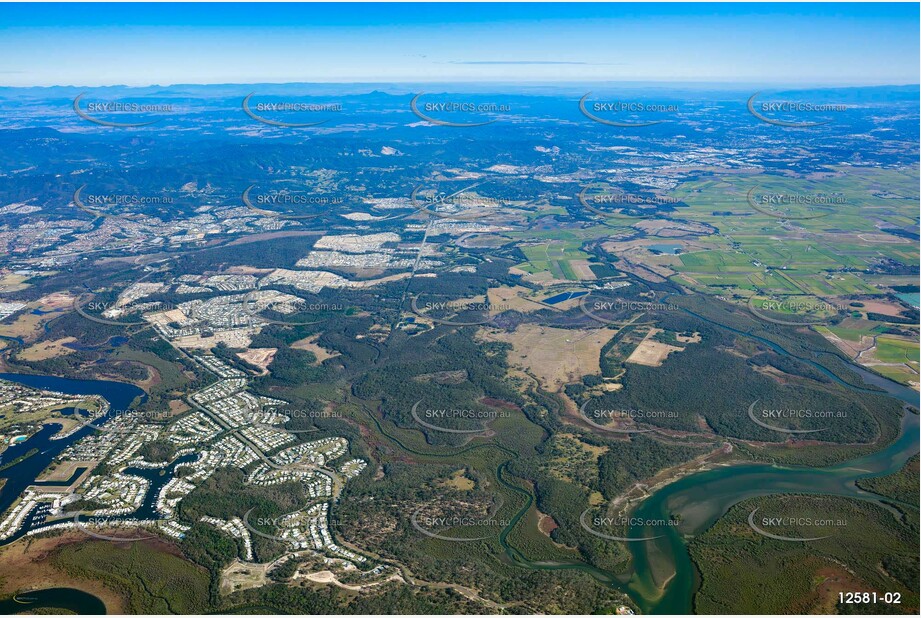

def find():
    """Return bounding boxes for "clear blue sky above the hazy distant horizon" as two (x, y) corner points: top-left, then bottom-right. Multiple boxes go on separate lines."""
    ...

(0, 3), (919, 86)
